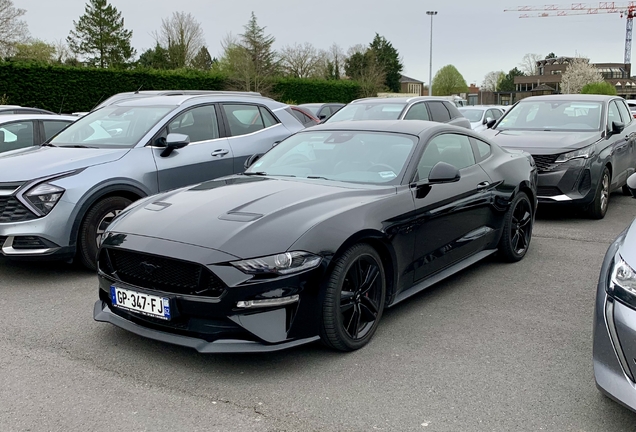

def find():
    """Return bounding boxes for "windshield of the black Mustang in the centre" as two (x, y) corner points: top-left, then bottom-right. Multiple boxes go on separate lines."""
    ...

(245, 131), (418, 184)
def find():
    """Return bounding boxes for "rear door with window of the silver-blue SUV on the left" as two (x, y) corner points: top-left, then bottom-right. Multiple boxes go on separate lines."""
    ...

(221, 103), (290, 172)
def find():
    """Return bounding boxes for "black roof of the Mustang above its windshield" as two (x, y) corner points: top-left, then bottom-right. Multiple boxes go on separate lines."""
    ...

(306, 120), (448, 135)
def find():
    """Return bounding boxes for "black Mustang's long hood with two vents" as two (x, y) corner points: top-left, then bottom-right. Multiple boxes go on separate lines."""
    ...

(109, 176), (396, 264)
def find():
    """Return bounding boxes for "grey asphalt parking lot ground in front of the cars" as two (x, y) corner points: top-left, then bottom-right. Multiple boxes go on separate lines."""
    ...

(0, 194), (636, 432)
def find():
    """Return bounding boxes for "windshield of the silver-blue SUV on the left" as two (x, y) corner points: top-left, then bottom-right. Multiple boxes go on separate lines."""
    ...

(50, 106), (174, 148)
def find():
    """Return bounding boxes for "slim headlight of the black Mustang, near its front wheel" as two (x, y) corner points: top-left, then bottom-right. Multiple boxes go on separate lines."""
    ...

(230, 252), (322, 275)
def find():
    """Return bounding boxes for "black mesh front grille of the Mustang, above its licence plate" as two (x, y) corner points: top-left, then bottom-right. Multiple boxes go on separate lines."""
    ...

(99, 249), (226, 297)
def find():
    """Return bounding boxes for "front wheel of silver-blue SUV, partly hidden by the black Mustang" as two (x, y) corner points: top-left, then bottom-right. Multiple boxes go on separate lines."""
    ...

(77, 196), (132, 270)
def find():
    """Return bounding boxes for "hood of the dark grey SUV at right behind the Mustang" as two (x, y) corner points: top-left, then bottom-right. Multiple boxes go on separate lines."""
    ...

(482, 129), (601, 154)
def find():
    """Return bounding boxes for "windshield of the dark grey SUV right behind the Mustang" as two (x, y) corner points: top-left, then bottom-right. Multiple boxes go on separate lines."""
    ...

(496, 100), (601, 132)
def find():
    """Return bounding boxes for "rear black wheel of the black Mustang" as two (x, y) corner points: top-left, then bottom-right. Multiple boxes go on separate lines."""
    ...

(499, 192), (534, 262)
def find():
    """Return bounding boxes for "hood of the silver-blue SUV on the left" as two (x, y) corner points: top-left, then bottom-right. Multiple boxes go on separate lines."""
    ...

(0, 147), (130, 182)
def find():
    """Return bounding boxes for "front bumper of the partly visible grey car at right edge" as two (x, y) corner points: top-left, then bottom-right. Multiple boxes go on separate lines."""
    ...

(593, 226), (636, 411)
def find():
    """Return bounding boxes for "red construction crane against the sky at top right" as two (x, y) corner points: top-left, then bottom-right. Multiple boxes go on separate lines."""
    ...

(504, 1), (636, 64)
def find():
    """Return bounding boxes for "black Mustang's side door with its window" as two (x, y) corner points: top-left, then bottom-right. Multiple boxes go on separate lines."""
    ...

(412, 133), (493, 281)
